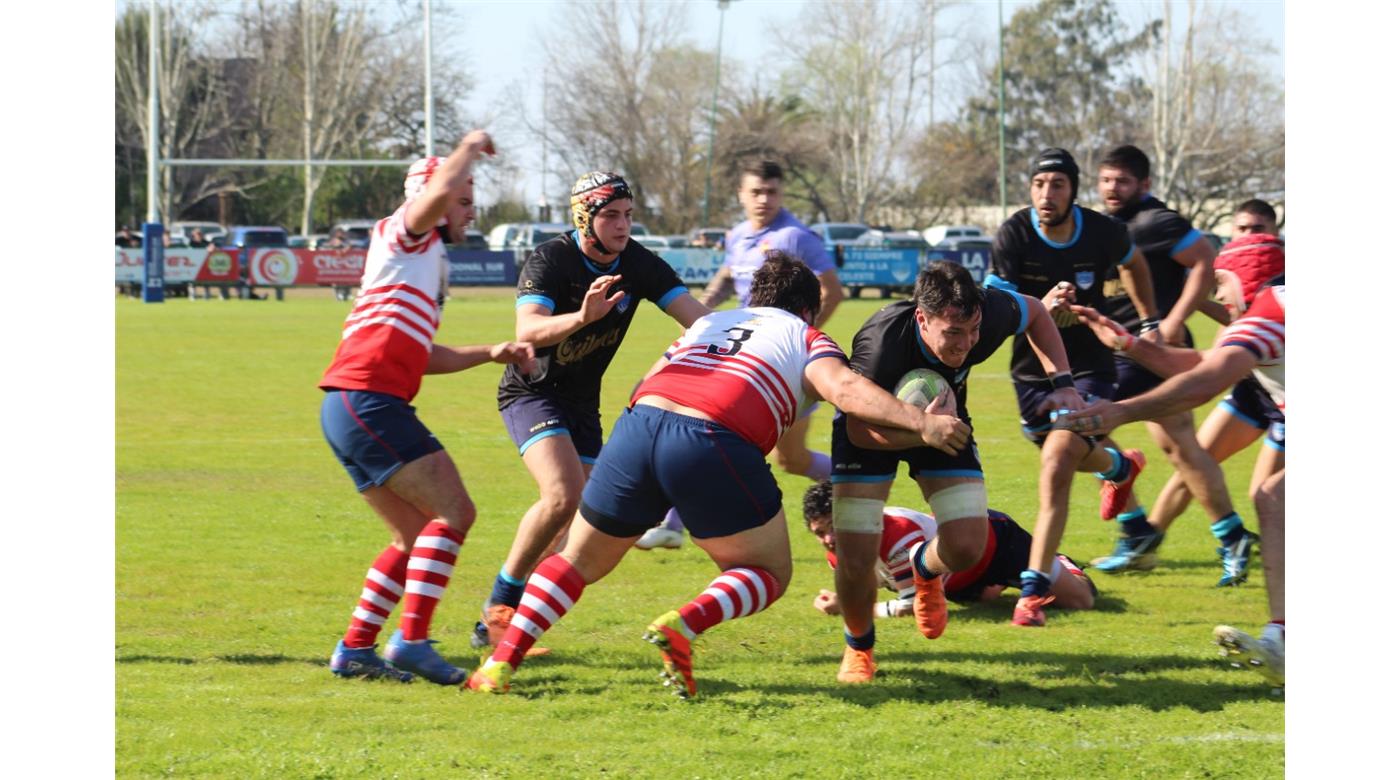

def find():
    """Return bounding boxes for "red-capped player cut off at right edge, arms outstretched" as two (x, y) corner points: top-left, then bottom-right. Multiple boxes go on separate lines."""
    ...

(1057, 261), (1285, 686)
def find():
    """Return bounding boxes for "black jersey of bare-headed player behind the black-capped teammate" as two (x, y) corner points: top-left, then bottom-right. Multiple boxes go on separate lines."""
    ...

(1099, 195), (1201, 331)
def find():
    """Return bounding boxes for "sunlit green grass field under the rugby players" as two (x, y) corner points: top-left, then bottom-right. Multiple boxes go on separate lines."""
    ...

(116, 290), (1284, 779)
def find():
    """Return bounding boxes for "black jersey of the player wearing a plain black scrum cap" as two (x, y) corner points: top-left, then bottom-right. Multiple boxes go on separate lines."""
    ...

(987, 206), (1133, 382)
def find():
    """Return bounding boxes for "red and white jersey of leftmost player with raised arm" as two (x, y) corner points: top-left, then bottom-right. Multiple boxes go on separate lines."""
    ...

(321, 203), (447, 401)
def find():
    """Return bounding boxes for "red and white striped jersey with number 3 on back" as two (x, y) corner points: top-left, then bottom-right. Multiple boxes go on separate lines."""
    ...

(631, 307), (846, 452)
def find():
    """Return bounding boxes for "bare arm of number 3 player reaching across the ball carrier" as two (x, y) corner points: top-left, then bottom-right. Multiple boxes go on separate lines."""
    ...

(804, 357), (972, 455)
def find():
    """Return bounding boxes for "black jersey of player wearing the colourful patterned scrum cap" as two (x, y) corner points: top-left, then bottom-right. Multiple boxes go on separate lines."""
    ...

(496, 231), (686, 409)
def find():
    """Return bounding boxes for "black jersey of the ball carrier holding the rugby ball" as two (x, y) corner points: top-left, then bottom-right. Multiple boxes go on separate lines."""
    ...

(850, 288), (1044, 424)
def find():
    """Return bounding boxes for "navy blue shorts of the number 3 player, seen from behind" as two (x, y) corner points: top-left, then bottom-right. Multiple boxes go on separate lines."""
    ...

(578, 406), (783, 539)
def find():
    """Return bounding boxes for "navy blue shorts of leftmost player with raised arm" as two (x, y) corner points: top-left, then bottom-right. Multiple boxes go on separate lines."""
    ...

(321, 389), (442, 492)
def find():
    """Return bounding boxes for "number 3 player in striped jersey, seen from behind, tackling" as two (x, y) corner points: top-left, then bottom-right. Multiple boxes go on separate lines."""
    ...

(468, 252), (969, 697)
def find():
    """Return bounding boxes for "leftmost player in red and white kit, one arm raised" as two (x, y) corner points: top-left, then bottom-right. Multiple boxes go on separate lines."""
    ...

(321, 130), (533, 685)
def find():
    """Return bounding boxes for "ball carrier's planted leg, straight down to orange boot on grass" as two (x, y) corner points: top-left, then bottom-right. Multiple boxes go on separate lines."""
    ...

(832, 482), (892, 682)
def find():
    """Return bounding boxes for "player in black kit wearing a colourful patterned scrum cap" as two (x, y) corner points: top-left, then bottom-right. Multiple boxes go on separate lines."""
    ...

(472, 172), (710, 647)
